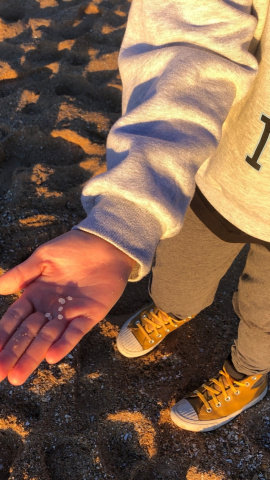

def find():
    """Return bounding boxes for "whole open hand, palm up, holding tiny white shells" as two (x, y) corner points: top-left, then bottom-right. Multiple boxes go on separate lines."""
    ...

(0, 230), (134, 385)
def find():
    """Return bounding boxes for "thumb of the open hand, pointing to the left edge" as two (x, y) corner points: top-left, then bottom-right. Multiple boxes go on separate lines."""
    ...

(0, 253), (42, 295)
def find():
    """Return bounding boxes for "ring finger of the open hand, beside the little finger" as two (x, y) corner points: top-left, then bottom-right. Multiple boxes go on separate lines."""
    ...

(8, 319), (68, 385)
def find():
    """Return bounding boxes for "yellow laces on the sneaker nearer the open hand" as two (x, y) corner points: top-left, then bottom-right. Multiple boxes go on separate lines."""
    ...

(136, 308), (181, 343)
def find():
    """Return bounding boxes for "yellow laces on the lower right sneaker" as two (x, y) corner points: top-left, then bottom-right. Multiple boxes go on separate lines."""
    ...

(194, 369), (249, 413)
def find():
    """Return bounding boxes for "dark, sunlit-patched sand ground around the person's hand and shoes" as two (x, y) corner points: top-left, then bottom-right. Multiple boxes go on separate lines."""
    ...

(0, 0), (270, 480)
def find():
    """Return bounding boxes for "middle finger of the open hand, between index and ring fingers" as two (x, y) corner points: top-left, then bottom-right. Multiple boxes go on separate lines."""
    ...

(0, 313), (46, 381)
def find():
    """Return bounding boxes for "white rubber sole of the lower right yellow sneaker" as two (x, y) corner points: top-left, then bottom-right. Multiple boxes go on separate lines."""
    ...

(171, 387), (267, 432)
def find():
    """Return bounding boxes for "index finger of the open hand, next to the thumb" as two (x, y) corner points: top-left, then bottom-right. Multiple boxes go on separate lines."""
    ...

(0, 296), (33, 351)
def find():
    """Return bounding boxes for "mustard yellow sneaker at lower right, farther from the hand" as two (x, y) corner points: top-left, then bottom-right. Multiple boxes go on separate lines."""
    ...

(171, 367), (267, 432)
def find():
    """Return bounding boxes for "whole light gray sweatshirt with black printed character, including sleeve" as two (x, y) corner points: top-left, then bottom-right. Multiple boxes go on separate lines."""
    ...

(76, 0), (270, 280)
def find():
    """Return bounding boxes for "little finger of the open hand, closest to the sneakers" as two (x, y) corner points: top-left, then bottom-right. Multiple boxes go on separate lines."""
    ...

(46, 317), (96, 363)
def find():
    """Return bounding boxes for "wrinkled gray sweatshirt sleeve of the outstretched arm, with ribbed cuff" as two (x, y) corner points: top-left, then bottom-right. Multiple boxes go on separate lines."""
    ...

(75, 0), (258, 280)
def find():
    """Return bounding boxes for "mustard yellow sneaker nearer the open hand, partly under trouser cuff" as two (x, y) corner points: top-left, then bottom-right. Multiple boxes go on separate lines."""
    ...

(116, 303), (194, 358)
